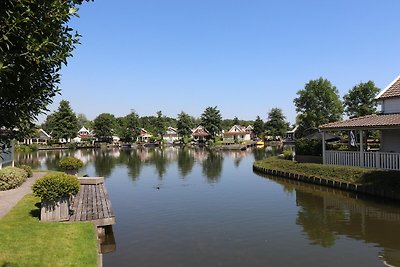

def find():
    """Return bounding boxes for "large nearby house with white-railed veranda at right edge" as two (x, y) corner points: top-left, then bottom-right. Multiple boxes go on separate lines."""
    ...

(319, 76), (400, 170)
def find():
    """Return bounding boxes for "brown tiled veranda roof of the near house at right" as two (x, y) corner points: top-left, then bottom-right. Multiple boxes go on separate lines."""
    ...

(319, 114), (400, 130)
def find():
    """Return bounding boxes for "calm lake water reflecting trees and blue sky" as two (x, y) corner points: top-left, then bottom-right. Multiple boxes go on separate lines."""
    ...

(17, 148), (400, 267)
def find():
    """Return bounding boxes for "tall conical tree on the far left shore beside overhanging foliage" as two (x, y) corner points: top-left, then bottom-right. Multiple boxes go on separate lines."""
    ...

(49, 100), (79, 140)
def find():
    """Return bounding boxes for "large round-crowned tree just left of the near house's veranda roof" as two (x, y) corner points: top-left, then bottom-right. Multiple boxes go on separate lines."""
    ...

(293, 77), (343, 134)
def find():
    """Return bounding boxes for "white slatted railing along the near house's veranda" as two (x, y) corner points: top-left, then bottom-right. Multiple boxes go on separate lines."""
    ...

(325, 150), (400, 170)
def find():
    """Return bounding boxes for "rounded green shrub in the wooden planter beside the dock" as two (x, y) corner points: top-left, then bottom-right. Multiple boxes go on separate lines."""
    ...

(32, 172), (80, 201)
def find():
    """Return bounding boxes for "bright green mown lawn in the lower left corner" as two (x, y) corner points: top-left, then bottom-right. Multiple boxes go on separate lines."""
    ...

(0, 195), (97, 267)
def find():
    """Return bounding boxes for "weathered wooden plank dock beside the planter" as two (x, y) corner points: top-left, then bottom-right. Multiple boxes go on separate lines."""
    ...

(69, 177), (115, 227)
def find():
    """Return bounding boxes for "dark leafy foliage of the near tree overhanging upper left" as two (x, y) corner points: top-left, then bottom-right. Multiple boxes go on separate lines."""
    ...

(0, 0), (90, 147)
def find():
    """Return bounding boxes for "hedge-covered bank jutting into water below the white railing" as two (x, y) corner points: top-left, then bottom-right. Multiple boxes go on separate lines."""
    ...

(254, 157), (400, 192)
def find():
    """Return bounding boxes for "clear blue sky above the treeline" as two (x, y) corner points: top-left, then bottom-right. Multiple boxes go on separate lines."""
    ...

(41, 0), (400, 123)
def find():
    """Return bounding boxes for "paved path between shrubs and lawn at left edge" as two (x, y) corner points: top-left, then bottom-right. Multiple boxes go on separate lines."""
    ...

(0, 172), (46, 218)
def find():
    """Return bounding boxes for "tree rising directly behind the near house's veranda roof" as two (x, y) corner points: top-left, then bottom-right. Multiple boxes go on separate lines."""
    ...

(343, 81), (380, 118)
